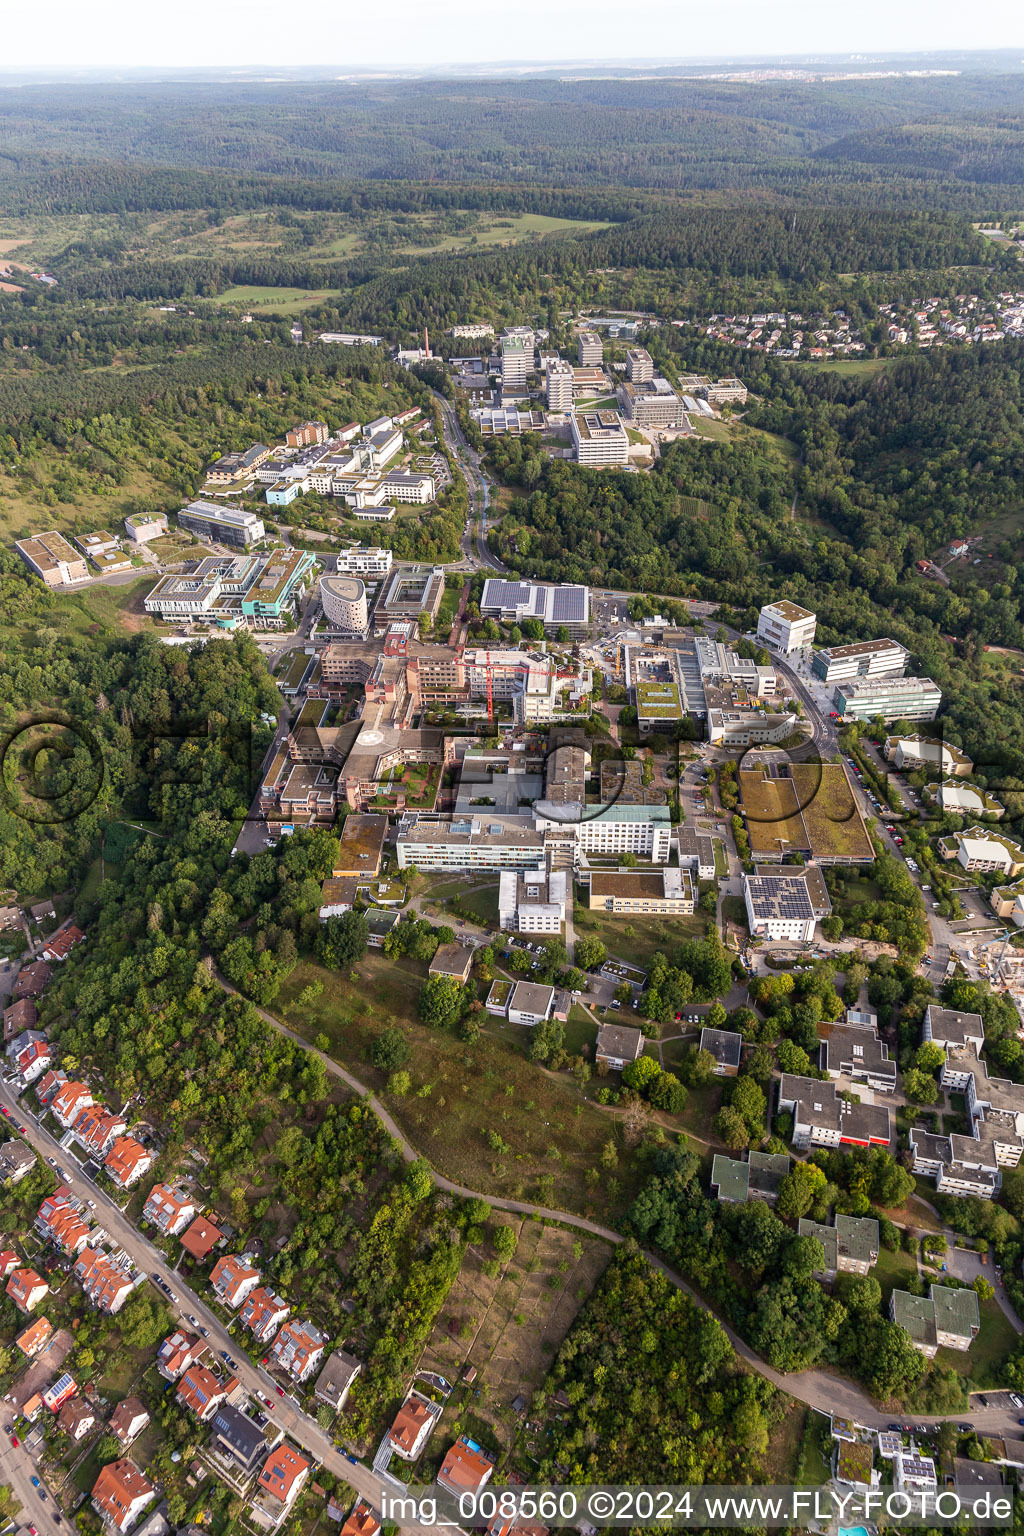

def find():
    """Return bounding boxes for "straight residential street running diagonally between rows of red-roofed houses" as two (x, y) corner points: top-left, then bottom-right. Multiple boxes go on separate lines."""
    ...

(0, 1087), (436, 1536)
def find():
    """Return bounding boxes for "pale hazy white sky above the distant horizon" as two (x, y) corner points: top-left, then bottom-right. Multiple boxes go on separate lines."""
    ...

(0, 0), (1024, 69)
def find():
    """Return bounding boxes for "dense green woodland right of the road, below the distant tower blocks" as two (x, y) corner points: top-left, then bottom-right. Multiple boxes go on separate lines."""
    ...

(490, 343), (1024, 791)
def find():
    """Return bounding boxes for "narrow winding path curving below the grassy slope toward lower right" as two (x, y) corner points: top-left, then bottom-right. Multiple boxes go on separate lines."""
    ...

(205, 966), (1016, 1436)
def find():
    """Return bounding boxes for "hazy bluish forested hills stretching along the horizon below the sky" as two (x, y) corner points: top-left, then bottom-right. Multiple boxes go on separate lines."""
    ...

(0, 69), (1022, 209)
